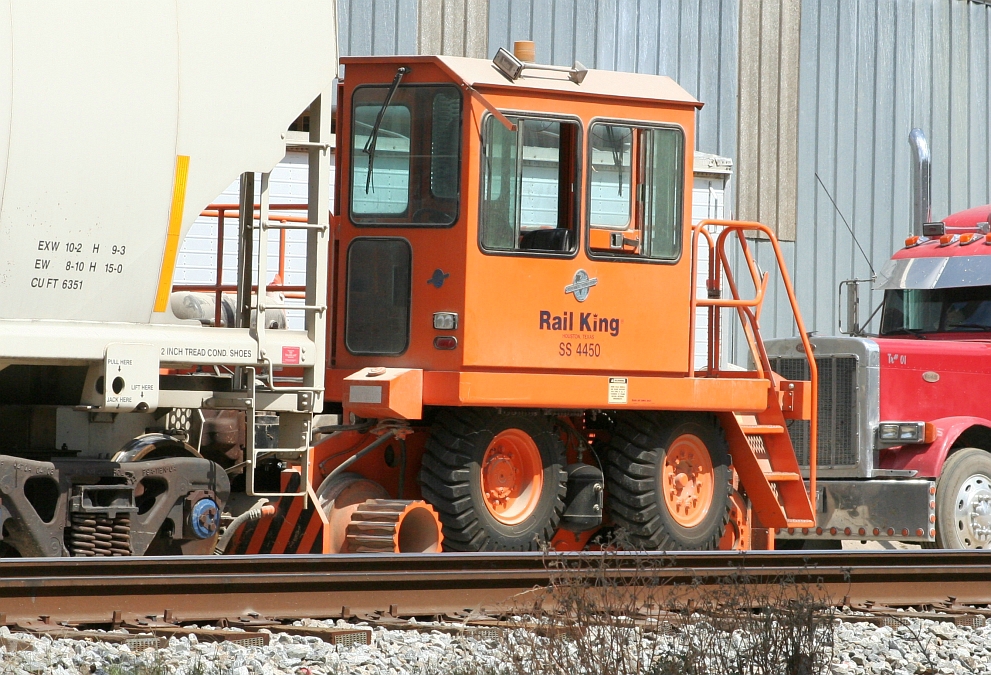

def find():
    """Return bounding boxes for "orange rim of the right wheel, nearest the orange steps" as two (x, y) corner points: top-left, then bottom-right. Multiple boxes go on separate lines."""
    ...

(661, 434), (715, 527)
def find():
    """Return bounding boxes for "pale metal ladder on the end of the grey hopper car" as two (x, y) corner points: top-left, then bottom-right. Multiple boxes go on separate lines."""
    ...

(238, 93), (332, 507)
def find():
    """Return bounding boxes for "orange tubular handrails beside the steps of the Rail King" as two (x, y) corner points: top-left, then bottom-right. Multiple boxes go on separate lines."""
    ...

(689, 220), (819, 503)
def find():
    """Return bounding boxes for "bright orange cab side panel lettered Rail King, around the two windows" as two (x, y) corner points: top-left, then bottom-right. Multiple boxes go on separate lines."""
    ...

(463, 95), (695, 374)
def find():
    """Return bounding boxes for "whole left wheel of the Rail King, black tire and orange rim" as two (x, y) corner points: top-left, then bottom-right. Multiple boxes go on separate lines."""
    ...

(420, 409), (567, 551)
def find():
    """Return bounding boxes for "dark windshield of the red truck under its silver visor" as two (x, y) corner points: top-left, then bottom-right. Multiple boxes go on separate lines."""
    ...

(880, 286), (991, 335)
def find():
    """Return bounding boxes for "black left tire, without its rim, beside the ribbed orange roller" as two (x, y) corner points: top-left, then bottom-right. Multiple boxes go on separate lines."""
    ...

(420, 408), (567, 551)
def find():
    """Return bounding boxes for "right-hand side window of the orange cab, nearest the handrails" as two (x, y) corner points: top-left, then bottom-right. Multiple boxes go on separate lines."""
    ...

(588, 122), (685, 260)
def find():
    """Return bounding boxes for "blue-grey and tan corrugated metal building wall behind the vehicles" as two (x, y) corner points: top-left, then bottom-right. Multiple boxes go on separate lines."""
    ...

(340, 0), (991, 361)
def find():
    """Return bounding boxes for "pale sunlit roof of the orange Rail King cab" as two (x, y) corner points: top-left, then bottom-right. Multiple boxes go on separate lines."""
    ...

(341, 56), (703, 108)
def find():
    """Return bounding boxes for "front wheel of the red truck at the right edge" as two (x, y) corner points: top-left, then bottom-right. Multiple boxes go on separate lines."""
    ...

(936, 448), (991, 549)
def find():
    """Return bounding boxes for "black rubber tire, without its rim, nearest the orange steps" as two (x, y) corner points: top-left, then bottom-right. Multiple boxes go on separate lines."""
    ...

(606, 412), (733, 551)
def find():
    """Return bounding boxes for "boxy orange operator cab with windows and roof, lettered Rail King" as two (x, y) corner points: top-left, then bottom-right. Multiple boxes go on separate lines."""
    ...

(328, 56), (701, 404)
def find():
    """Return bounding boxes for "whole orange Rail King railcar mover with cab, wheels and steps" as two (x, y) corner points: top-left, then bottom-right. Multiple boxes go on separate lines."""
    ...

(237, 51), (816, 552)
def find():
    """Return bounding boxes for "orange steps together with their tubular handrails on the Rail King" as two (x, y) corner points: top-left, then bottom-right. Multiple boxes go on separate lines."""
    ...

(689, 220), (818, 529)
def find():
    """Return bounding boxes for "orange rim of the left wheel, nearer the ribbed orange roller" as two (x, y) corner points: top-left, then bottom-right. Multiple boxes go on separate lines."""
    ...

(482, 429), (544, 525)
